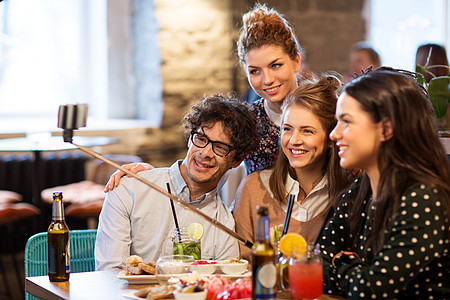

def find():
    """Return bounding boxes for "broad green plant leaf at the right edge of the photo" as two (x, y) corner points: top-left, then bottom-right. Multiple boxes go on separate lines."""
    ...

(428, 76), (450, 119)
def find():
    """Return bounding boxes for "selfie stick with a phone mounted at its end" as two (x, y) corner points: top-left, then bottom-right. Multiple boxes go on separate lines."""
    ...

(58, 104), (253, 248)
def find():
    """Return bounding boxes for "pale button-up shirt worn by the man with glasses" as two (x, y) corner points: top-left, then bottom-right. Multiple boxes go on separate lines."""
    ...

(95, 160), (239, 270)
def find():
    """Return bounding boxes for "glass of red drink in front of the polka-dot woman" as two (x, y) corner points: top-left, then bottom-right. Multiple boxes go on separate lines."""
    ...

(289, 244), (323, 299)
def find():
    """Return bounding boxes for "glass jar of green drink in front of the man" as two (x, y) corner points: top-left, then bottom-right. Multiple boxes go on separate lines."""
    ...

(163, 227), (201, 260)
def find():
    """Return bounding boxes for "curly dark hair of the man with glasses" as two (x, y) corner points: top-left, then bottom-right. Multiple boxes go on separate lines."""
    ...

(183, 94), (260, 161)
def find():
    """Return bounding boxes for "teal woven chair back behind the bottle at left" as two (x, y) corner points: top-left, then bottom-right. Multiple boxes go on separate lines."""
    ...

(24, 229), (97, 299)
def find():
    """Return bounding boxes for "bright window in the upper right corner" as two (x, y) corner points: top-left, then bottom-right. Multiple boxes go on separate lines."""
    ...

(368, 0), (450, 71)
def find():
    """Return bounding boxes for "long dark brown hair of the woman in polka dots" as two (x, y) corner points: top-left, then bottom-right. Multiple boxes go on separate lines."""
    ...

(343, 67), (450, 253)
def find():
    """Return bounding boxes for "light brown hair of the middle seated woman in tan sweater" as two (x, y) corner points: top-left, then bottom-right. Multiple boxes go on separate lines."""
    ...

(269, 73), (350, 204)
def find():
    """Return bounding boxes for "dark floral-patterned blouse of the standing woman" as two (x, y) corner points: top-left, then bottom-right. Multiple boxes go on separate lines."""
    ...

(245, 98), (280, 174)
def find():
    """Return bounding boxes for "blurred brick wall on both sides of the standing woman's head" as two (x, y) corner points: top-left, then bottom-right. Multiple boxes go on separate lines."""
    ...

(137, 0), (365, 166)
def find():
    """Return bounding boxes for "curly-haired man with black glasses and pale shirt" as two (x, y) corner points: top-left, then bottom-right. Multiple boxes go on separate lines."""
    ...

(95, 95), (259, 270)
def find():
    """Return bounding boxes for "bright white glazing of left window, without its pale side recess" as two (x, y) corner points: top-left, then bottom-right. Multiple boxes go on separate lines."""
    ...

(0, 0), (107, 116)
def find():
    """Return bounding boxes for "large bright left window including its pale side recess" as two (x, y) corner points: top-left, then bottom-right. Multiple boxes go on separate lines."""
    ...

(0, 0), (162, 126)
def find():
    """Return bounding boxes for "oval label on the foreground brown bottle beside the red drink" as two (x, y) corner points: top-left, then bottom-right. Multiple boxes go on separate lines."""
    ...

(255, 262), (277, 299)
